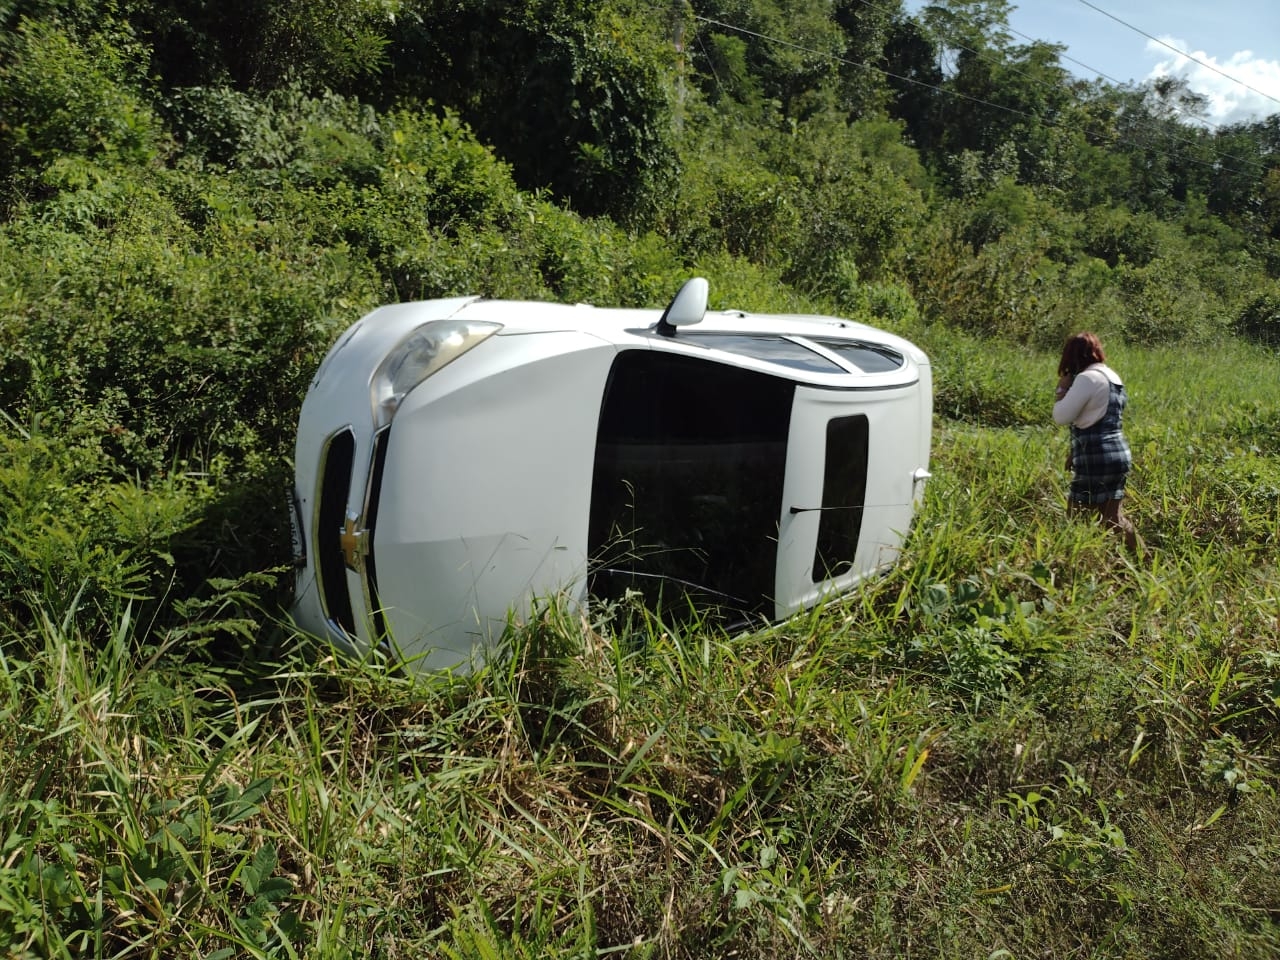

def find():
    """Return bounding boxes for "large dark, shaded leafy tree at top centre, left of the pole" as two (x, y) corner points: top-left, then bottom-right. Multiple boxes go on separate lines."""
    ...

(381, 0), (682, 220)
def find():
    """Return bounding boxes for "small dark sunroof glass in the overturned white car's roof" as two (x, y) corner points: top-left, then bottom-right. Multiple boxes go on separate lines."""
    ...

(813, 413), (867, 582)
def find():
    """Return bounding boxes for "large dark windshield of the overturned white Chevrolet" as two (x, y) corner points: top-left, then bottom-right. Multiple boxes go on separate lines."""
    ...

(590, 349), (795, 616)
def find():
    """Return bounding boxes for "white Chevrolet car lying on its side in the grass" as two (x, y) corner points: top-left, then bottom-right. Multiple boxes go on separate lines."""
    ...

(293, 278), (932, 671)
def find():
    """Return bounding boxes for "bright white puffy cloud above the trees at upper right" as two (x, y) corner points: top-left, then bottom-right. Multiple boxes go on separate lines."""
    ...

(1147, 37), (1280, 124)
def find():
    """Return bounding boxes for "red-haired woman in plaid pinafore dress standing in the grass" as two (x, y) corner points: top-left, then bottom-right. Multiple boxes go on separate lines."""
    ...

(1053, 333), (1138, 549)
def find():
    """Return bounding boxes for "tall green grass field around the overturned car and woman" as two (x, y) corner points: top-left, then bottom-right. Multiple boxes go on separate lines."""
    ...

(0, 332), (1280, 960)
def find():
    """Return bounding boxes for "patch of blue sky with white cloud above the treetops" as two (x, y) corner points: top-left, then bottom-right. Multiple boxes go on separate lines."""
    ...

(905, 0), (1280, 124)
